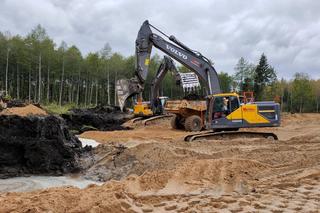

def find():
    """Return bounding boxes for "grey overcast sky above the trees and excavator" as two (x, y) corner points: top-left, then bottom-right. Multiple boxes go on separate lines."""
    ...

(0, 0), (320, 79)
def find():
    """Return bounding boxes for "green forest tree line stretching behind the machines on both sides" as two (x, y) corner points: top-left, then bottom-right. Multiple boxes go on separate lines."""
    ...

(0, 25), (320, 112)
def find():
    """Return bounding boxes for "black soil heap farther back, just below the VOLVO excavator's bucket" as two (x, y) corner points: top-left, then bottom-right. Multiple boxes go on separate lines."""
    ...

(61, 106), (132, 133)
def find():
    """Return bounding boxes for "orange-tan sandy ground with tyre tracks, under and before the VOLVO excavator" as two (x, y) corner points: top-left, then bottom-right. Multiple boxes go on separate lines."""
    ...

(0, 114), (320, 212)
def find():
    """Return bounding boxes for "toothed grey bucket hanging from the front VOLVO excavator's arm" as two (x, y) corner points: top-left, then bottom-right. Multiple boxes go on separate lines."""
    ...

(116, 78), (143, 111)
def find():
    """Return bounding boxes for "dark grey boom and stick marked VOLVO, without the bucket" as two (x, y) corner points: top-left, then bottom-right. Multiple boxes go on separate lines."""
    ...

(136, 21), (221, 95)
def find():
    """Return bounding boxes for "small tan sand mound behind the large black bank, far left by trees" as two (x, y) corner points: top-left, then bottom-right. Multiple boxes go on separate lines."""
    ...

(0, 104), (48, 117)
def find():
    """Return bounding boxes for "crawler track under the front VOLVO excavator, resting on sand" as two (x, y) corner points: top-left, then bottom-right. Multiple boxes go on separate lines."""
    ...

(184, 131), (278, 142)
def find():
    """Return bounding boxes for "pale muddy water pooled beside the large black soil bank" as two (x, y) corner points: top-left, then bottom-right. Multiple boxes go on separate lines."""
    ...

(0, 138), (102, 192)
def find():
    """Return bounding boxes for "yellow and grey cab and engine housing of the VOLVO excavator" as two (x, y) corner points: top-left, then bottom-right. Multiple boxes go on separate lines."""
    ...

(207, 93), (280, 130)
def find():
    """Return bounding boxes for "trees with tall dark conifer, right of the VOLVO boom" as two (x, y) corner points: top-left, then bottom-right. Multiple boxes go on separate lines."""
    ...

(230, 54), (320, 113)
